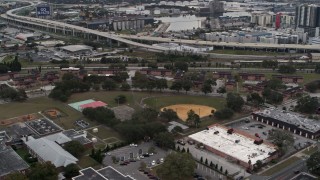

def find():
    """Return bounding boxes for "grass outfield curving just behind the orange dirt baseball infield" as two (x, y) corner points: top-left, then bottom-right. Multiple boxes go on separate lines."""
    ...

(144, 95), (226, 109)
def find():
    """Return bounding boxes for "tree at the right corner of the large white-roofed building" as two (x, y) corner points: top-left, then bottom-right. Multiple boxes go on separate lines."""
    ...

(268, 129), (294, 154)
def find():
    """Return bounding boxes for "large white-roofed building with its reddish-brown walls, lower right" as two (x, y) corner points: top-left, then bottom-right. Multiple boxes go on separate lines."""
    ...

(189, 124), (277, 168)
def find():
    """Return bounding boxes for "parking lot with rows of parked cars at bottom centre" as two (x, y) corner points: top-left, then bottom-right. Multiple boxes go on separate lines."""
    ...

(103, 142), (169, 180)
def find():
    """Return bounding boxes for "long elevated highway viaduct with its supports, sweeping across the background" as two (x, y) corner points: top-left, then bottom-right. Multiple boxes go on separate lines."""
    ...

(1, 3), (320, 54)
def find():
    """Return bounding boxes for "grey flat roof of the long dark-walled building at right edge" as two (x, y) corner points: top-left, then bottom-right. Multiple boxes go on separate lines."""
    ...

(253, 108), (320, 133)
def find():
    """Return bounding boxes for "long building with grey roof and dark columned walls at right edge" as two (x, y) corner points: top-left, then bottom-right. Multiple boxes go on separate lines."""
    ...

(252, 108), (320, 139)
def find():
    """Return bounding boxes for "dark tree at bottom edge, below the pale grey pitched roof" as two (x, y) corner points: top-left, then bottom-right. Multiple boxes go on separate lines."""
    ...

(28, 162), (59, 180)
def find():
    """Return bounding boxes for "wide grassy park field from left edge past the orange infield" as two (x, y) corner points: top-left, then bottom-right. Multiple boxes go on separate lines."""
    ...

(0, 91), (225, 130)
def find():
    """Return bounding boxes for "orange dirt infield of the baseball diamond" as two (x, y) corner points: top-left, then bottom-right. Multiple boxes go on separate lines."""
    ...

(161, 104), (216, 121)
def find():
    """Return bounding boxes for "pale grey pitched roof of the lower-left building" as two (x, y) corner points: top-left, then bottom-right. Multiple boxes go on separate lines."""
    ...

(23, 136), (78, 167)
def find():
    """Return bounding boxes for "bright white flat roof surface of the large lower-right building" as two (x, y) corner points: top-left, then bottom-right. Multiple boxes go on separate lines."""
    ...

(189, 125), (276, 164)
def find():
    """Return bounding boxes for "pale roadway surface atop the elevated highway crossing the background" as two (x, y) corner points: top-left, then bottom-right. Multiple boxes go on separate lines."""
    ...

(1, 3), (319, 51)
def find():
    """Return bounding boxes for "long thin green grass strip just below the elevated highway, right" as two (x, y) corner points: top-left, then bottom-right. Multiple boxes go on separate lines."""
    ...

(210, 49), (289, 56)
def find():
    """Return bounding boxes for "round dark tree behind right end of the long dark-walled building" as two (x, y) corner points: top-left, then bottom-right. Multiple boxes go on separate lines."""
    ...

(296, 96), (320, 114)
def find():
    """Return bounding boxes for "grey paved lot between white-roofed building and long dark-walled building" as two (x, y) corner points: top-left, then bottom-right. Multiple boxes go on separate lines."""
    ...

(227, 117), (315, 153)
